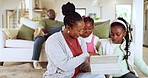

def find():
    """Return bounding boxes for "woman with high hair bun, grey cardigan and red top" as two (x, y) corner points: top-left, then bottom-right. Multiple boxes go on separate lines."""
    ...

(43, 2), (104, 78)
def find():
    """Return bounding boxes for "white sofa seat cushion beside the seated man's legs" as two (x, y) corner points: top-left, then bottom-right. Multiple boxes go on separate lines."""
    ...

(5, 39), (45, 48)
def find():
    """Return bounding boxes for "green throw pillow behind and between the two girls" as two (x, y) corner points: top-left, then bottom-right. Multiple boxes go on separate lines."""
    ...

(93, 20), (110, 39)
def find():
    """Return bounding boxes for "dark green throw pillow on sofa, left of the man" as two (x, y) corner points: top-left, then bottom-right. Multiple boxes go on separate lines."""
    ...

(17, 25), (34, 40)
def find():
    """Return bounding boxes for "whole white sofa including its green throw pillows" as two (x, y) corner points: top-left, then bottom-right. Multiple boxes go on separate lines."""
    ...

(0, 18), (110, 62)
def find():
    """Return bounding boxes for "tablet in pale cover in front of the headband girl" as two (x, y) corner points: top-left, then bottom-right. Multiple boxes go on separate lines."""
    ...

(90, 55), (121, 74)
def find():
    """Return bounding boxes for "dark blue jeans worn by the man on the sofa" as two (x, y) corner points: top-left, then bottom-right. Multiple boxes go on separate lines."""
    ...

(32, 26), (62, 60)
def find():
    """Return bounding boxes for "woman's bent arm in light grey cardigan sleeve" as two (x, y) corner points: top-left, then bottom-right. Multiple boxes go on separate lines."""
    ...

(45, 37), (88, 71)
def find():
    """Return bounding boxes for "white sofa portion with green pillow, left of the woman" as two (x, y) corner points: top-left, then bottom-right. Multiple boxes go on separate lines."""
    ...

(0, 18), (47, 62)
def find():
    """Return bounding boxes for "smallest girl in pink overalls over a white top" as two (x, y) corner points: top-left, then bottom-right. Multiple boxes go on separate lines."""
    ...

(81, 16), (99, 55)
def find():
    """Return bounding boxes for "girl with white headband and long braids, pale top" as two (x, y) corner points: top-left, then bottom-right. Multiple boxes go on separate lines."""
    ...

(99, 18), (148, 78)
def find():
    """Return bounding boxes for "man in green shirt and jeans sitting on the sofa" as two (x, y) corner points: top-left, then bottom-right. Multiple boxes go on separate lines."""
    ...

(32, 9), (63, 69)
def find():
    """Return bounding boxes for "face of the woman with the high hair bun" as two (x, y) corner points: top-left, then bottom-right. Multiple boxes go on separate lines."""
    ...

(69, 21), (84, 39)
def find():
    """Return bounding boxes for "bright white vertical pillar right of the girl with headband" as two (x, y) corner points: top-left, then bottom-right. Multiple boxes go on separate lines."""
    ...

(132, 0), (144, 57)
